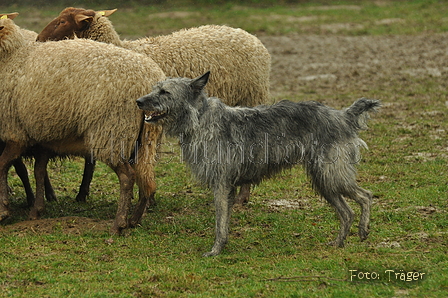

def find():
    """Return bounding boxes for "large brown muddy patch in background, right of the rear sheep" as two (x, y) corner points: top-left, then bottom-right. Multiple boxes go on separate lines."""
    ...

(259, 33), (448, 101)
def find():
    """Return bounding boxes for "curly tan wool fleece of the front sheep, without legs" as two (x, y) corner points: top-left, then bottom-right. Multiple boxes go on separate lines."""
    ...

(0, 20), (165, 164)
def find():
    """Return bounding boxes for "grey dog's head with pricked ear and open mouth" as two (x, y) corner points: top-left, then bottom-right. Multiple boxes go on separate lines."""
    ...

(137, 72), (210, 130)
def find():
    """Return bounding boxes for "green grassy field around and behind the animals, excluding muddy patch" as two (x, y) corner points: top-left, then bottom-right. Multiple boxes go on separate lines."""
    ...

(0, 1), (448, 297)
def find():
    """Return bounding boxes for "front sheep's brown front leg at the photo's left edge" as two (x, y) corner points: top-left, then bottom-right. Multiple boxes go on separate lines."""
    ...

(0, 142), (25, 221)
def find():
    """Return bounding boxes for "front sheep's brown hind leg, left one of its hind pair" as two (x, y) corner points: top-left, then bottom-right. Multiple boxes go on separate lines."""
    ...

(110, 163), (135, 235)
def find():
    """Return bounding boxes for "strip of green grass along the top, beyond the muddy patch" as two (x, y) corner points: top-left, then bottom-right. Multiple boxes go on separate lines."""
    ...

(0, 0), (448, 38)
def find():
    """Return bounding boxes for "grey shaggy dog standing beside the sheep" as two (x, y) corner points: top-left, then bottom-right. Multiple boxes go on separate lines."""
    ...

(137, 73), (380, 256)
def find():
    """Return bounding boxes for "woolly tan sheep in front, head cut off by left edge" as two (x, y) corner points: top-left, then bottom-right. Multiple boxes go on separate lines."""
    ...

(0, 19), (165, 233)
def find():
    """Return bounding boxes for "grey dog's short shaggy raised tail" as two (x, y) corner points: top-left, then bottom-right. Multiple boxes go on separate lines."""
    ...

(345, 97), (381, 129)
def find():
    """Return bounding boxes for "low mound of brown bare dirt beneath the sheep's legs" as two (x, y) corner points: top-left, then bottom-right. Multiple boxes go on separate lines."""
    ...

(0, 216), (112, 235)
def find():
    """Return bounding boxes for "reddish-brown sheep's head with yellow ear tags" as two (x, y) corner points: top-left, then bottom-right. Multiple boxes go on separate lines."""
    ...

(37, 7), (116, 42)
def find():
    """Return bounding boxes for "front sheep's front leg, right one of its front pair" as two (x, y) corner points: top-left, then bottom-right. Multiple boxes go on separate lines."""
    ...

(29, 150), (50, 220)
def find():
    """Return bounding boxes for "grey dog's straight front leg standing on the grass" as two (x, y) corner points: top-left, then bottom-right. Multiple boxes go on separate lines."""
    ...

(203, 185), (235, 257)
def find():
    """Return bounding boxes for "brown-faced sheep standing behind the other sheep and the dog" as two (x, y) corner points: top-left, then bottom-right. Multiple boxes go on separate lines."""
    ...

(37, 7), (271, 203)
